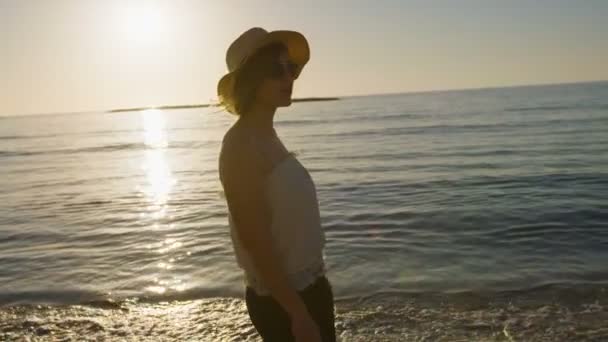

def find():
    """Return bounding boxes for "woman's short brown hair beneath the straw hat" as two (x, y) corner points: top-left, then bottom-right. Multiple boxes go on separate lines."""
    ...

(227, 43), (287, 116)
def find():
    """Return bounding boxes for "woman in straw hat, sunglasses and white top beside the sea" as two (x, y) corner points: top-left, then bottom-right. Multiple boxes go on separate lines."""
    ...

(218, 28), (335, 342)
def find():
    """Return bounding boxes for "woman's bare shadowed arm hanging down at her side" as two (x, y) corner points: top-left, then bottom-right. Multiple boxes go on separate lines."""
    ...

(220, 139), (308, 317)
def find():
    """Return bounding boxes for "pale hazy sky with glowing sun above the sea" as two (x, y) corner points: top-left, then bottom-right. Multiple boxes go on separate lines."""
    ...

(0, 0), (608, 116)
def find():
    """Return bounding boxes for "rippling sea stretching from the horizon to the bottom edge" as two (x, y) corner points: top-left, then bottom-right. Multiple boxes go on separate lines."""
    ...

(0, 82), (608, 341)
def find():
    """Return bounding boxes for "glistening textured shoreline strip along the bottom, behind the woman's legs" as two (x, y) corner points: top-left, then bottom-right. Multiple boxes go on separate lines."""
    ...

(0, 285), (608, 342)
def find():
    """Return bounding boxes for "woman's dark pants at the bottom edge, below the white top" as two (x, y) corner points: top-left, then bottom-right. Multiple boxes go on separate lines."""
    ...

(245, 277), (336, 342)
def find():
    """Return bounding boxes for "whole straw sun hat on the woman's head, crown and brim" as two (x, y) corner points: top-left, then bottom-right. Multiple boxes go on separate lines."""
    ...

(217, 27), (310, 113)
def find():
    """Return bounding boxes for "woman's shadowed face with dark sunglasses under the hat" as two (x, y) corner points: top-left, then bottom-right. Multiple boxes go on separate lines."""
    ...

(256, 50), (297, 107)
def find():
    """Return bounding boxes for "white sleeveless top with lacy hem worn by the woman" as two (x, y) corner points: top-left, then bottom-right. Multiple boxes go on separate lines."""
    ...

(228, 154), (325, 295)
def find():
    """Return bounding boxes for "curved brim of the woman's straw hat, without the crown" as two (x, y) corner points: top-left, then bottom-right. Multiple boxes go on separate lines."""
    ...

(217, 30), (310, 114)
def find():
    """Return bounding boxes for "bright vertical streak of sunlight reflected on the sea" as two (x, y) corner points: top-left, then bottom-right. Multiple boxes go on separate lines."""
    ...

(141, 109), (185, 294)
